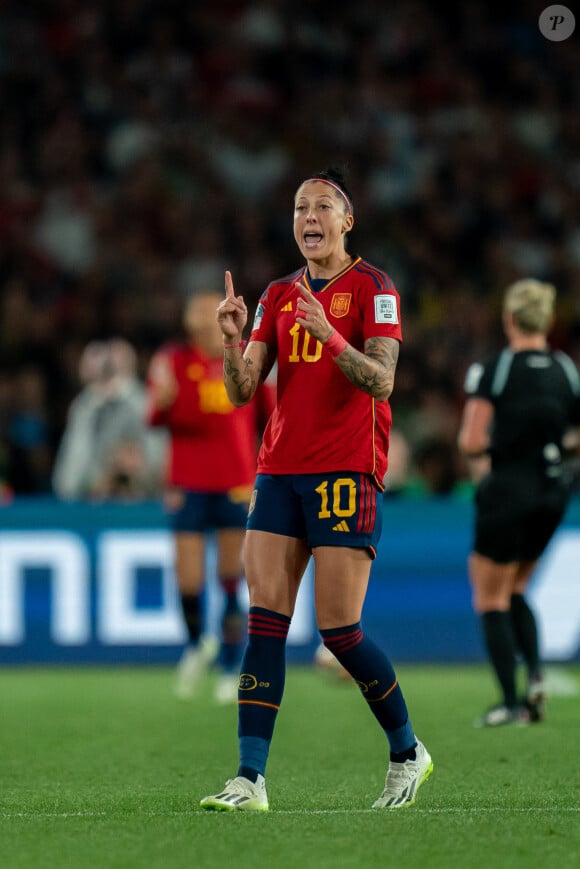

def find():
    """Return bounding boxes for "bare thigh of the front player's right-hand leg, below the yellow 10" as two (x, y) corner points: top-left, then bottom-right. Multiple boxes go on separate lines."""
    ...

(312, 546), (372, 630)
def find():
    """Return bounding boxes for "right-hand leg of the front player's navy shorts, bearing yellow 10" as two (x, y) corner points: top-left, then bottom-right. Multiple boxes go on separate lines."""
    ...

(295, 471), (383, 559)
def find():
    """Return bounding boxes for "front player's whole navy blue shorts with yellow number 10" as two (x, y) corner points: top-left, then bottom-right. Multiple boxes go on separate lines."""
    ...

(247, 471), (383, 558)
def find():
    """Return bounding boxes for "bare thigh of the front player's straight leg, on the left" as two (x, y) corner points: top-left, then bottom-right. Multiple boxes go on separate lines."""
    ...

(244, 530), (310, 616)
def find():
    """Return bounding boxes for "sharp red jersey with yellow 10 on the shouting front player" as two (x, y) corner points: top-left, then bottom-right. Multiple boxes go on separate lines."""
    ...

(250, 257), (402, 487)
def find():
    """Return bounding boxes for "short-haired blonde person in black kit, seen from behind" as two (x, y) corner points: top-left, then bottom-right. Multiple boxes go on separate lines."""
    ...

(459, 279), (580, 727)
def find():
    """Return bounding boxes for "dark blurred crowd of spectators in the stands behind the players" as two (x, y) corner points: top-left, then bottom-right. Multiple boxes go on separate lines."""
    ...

(0, 0), (580, 497)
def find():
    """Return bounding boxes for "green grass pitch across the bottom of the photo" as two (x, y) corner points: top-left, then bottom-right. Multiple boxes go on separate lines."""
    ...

(0, 667), (580, 869)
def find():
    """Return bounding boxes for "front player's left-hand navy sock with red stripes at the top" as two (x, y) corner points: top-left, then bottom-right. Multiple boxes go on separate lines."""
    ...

(237, 607), (290, 782)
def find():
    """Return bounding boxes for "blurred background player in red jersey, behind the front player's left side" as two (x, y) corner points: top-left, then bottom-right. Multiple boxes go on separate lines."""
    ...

(148, 291), (271, 702)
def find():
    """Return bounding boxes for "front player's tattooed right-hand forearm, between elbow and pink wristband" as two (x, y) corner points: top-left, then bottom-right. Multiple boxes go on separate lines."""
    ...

(334, 338), (399, 401)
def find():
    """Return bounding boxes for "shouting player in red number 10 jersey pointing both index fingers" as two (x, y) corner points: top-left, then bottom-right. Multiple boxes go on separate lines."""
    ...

(201, 171), (433, 811)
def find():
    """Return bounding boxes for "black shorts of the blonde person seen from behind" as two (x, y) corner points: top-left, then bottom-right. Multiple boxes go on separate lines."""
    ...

(473, 471), (568, 564)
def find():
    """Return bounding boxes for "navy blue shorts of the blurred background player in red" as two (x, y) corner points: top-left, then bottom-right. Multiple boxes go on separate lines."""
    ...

(165, 489), (250, 534)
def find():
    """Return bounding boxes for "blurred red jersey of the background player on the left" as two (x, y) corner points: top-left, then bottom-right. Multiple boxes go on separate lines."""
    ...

(148, 345), (271, 492)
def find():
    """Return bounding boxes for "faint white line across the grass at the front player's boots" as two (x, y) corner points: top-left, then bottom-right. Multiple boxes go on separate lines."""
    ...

(0, 806), (580, 820)
